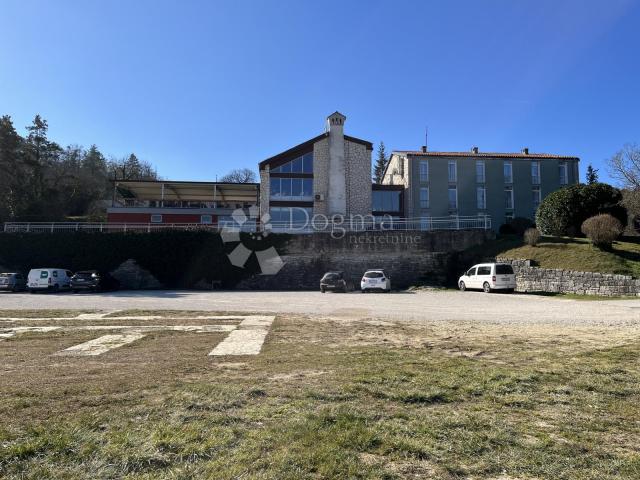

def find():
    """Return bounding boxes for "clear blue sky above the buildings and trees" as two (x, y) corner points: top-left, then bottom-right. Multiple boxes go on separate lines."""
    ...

(0, 0), (640, 184)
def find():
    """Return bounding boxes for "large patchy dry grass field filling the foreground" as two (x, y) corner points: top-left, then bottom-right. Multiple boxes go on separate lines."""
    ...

(0, 312), (640, 480)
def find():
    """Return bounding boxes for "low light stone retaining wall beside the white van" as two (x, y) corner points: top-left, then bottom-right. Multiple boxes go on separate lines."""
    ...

(496, 258), (640, 297)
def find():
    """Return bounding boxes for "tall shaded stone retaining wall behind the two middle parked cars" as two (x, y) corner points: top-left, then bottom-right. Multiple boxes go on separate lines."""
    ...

(237, 230), (495, 290)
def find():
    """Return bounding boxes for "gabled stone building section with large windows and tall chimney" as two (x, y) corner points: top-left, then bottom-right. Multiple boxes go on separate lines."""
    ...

(259, 112), (373, 224)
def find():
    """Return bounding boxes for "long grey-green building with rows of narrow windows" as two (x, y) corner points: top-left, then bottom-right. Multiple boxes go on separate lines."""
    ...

(382, 147), (580, 229)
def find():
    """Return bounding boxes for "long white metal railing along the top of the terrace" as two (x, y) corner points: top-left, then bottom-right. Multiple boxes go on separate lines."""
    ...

(3, 216), (491, 233)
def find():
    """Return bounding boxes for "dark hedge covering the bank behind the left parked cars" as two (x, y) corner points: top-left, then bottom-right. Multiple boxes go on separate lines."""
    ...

(0, 230), (288, 288)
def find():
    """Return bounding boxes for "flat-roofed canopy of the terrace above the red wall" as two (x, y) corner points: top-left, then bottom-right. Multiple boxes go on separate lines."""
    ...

(114, 180), (260, 204)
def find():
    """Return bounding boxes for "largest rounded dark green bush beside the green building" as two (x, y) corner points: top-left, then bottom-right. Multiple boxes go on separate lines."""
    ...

(536, 183), (627, 236)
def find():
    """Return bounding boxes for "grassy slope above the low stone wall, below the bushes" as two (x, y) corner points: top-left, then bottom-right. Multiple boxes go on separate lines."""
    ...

(470, 236), (640, 278)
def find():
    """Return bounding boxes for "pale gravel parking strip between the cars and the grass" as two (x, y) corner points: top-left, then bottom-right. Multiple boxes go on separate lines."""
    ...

(0, 290), (640, 326)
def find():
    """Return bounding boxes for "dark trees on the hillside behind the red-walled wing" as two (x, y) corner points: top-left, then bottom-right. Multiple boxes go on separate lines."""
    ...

(0, 115), (158, 223)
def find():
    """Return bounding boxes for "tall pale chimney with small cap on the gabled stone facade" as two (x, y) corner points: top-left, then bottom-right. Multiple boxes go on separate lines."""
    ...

(327, 112), (347, 215)
